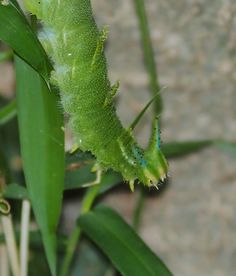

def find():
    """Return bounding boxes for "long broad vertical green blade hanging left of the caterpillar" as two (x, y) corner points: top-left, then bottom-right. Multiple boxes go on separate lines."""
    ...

(16, 57), (64, 275)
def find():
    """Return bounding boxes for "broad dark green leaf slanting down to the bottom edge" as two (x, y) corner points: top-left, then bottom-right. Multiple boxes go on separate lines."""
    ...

(78, 206), (172, 276)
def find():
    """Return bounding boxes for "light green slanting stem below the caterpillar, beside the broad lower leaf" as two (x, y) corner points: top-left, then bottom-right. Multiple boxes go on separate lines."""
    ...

(60, 185), (100, 276)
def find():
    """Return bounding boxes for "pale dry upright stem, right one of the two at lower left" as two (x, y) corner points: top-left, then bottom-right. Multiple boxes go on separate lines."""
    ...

(20, 199), (30, 276)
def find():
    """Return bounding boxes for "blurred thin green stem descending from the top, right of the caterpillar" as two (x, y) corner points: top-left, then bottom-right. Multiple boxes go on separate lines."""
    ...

(134, 0), (163, 114)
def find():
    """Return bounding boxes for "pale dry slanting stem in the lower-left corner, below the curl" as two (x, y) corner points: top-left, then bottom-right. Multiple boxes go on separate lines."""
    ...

(1, 215), (20, 276)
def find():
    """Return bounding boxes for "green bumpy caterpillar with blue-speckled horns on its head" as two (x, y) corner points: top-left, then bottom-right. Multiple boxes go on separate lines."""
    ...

(25, 0), (168, 186)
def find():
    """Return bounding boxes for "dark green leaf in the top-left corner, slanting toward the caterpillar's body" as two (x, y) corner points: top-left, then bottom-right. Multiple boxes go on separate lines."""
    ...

(0, 1), (52, 80)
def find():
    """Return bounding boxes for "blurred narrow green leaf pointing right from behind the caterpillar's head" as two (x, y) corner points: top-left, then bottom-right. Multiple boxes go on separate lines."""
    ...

(162, 140), (215, 158)
